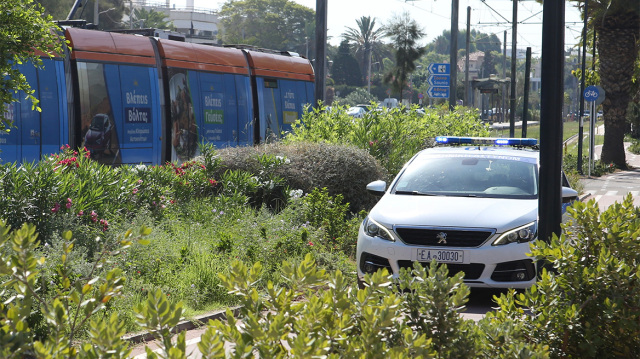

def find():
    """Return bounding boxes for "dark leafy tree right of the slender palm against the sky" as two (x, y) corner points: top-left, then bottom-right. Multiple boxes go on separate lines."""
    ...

(384, 12), (425, 101)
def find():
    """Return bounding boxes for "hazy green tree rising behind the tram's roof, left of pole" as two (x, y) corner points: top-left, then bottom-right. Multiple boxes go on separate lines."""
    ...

(220, 0), (315, 51)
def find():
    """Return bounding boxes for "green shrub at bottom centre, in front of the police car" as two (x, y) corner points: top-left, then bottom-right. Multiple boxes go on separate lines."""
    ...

(198, 255), (546, 358)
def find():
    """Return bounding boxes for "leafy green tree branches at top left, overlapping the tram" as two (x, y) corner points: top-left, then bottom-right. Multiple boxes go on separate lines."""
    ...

(0, 0), (65, 131)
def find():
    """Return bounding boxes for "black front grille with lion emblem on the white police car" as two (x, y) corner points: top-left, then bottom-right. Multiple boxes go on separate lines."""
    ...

(395, 227), (493, 247)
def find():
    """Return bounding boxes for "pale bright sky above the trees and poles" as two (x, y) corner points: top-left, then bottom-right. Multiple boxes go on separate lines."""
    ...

(170, 0), (582, 57)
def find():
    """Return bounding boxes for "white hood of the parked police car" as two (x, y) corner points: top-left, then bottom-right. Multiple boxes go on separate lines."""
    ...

(369, 194), (538, 233)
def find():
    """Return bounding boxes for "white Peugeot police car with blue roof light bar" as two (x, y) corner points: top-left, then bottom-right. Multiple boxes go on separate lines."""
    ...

(357, 136), (578, 288)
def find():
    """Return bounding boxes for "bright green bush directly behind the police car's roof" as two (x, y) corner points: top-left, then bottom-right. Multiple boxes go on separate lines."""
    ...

(285, 107), (489, 177)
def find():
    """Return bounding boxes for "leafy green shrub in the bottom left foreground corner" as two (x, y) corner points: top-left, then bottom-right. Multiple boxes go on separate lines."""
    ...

(0, 222), (150, 358)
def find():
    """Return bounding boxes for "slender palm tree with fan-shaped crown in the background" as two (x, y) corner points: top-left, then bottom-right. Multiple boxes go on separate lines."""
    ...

(342, 16), (384, 91)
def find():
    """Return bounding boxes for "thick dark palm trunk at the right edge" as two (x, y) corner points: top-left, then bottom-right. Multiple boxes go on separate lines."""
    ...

(596, 14), (638, 169)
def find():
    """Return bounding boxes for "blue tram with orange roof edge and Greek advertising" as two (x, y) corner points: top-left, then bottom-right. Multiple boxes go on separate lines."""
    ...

(0, 28), (314, 165)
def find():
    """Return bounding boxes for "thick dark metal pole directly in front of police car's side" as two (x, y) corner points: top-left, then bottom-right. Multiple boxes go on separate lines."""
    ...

(538, 0), (565, 245)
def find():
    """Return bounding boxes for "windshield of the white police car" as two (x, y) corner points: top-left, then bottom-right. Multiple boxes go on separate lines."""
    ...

(393, 156), (538, 199)
